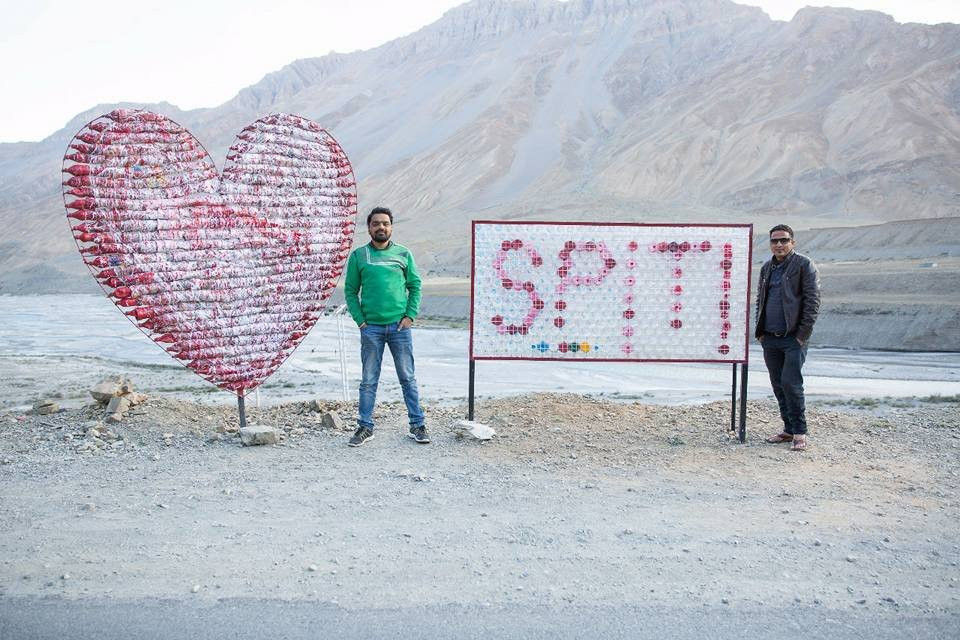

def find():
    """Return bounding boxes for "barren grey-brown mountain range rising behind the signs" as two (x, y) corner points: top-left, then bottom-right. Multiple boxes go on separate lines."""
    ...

(0, 0), (960, 292)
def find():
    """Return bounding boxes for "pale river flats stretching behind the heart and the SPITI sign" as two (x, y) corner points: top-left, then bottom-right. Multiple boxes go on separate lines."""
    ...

(0, 295), (960, 410)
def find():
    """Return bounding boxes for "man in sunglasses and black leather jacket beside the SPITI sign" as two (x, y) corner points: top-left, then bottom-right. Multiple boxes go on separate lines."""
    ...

(756, 224), (820, 451)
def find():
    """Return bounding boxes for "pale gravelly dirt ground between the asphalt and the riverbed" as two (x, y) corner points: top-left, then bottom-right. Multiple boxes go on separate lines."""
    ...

(0, 394), (960, 637)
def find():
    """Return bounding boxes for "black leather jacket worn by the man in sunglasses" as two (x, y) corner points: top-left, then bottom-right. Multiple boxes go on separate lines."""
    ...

(755, 251), (820, 342)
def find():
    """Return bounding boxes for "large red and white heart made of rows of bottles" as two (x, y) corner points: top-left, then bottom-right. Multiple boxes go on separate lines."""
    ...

(63, 109), (357, 395)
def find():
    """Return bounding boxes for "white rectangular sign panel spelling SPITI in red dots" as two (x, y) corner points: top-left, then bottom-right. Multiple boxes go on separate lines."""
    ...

(470, 221), (753, 363)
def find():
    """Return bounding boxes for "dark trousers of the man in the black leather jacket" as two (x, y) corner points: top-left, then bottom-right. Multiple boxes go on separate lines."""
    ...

(761, 334), (807, 435)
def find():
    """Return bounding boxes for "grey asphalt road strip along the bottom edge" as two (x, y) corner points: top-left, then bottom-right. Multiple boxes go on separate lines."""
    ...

(0, 594), (960, 640)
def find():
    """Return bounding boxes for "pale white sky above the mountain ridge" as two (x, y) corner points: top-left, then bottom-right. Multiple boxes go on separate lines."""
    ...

(0, 0), (960, 142)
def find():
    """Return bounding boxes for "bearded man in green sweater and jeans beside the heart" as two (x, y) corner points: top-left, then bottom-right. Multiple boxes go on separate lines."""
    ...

(343, 207), (430, 447)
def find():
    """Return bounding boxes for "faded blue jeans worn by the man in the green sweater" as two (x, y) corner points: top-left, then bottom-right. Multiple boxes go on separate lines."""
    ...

(357, 322), (423, 431)
